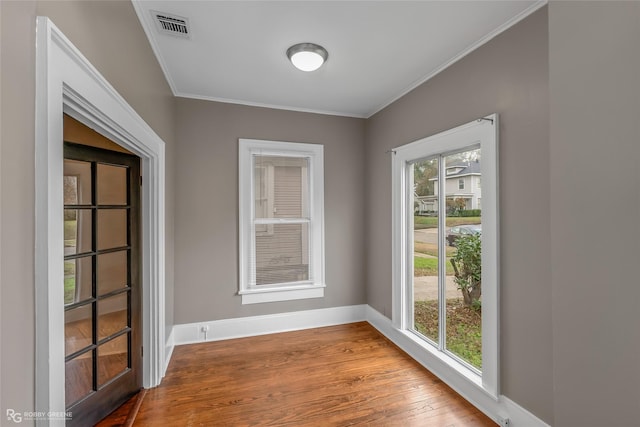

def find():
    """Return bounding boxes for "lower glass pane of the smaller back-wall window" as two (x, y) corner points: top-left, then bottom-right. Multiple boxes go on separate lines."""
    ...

(255, 224), (310, 285)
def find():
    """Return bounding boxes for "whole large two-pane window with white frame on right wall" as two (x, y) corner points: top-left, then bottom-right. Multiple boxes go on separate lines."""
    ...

(392, 114), (499, 397)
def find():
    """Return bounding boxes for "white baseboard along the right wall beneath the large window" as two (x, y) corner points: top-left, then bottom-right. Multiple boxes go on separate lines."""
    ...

(367, 305), (549, 427)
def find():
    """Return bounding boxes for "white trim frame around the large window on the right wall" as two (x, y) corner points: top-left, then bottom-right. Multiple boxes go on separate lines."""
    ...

(392, 114), (500, 398)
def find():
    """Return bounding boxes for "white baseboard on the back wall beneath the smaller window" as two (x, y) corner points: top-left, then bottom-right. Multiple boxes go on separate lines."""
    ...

(173, 304), (367, 345)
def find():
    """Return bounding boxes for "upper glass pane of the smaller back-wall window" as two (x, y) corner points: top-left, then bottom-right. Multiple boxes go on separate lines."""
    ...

(254, 156), (309, 219)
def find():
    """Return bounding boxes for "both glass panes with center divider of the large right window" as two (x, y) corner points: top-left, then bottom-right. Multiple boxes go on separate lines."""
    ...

(407, 146), (482, 372)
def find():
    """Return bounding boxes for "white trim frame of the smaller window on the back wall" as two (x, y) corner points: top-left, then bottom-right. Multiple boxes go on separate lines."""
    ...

(238, 138), (326, 304)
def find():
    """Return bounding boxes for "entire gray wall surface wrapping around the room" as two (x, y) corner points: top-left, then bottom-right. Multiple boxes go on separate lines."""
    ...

(5, 1), (640, 426)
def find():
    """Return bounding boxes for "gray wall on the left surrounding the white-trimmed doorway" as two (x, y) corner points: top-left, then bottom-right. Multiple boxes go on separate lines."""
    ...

(0, 1), (175, 425)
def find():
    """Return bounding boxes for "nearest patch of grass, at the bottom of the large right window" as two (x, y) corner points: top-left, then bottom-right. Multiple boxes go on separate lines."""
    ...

(414, 298), (482, 369)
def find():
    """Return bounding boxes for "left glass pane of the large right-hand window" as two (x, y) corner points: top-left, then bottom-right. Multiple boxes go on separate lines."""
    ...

(409, 157), (440, 344)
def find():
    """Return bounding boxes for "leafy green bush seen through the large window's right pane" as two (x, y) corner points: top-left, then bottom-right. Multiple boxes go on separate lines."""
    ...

(451, 234), (482, 308)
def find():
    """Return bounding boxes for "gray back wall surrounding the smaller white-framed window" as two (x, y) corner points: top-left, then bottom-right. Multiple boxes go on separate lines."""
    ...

(175, 99), (366, 324)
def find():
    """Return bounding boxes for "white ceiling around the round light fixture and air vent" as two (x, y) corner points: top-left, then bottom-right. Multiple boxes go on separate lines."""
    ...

(133, 0), (546, 117)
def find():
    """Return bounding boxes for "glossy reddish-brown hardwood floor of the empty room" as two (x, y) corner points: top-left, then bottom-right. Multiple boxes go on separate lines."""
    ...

(100, 322), (496, 427)
